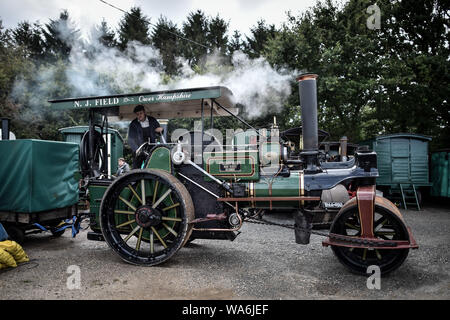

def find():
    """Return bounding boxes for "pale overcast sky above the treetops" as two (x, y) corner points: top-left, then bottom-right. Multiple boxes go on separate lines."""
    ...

(0, 0), (316, 36)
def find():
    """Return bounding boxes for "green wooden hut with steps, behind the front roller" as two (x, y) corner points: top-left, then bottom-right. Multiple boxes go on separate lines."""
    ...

(360, 133), (431, 209)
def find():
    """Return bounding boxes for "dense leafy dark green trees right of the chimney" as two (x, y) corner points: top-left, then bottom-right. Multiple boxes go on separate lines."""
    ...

(264, 0), (450, 145)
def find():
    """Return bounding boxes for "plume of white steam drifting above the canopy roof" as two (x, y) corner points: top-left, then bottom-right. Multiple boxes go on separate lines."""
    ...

(14, 23), (295, 118)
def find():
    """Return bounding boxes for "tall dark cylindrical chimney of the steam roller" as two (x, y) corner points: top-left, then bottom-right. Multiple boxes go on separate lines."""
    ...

(297, 73), (320, 173)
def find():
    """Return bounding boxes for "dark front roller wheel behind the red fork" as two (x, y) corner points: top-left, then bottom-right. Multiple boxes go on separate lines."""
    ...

(330, 205), (409, 275)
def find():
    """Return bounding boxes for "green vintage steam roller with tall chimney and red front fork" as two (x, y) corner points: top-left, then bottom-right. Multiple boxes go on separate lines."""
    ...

(49, 74), (418, 273)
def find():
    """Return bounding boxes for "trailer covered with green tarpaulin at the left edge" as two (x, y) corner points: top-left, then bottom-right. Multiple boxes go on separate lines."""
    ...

(0, 139), (78, 242)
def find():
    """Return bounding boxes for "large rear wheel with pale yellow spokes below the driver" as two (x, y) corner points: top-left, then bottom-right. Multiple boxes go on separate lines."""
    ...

(100, 169), (194, 266)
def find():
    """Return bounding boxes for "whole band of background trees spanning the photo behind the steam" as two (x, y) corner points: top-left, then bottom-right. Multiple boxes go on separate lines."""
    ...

(0, 0), (450, 148)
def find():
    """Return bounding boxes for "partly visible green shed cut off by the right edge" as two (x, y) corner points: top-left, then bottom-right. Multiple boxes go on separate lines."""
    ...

(431, 149), (450, 198)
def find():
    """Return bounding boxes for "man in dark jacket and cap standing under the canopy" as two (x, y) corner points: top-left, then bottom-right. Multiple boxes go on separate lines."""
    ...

(128, 105), (163, 169)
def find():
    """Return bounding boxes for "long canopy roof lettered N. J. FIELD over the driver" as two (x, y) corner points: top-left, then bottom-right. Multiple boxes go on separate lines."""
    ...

(49, 86), (238, 121)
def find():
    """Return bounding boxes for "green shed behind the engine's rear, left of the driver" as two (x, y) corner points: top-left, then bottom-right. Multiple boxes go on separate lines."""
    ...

(59, 126), (124, 174)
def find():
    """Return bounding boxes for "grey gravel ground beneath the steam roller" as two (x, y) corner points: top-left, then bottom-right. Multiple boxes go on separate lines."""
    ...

(0, 202), (450, 300)
